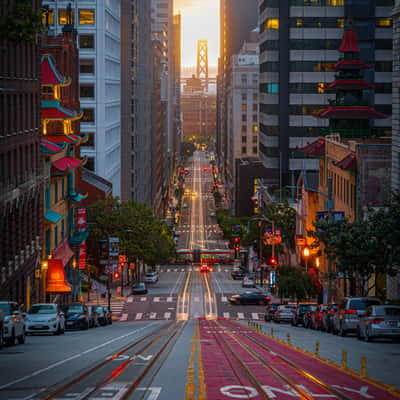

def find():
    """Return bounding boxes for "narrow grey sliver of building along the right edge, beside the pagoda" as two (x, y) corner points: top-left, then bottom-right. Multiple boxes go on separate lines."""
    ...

(392, 0), (400, 192)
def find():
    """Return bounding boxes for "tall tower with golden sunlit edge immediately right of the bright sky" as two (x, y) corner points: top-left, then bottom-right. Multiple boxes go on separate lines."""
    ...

(216, 0), (259, 181)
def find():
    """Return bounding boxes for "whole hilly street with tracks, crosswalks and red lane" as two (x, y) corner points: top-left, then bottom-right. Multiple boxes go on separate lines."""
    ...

(0, 153), (400, 400)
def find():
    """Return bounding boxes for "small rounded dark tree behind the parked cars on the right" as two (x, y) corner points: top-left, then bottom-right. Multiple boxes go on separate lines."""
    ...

(276, 266), (318, 301)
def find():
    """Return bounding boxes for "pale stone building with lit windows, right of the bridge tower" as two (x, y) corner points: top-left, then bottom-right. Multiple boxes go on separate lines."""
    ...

(226, 41), (260, 209)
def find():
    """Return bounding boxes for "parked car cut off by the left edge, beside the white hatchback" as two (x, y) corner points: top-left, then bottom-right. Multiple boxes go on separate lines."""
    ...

(0, 301), (25, 345)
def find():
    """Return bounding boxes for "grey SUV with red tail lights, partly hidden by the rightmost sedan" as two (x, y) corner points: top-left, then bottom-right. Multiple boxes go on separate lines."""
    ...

(332, 297), (381, 336)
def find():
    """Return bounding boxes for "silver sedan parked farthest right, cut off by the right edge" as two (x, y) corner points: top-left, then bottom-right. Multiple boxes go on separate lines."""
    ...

(357, 305), (400, 342)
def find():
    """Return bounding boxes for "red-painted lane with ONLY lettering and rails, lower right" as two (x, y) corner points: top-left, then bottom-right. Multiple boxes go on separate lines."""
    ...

(200, 319), (400, 400)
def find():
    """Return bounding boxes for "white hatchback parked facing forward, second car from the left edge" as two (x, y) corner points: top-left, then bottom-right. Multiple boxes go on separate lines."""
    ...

(25, 303), (65, 335)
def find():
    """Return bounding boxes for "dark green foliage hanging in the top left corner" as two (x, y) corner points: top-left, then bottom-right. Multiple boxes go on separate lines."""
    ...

(0, 0), (42, 43)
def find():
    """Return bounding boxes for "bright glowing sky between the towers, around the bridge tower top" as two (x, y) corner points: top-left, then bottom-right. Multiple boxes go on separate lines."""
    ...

(174, 0), (219, 71)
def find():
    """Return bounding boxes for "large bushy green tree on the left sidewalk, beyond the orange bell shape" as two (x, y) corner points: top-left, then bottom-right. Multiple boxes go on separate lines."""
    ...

(88, 198), (175, 265)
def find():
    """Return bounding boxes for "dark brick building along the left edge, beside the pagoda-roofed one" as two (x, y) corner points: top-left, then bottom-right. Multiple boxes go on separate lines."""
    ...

(0, 0), (43, 304)
